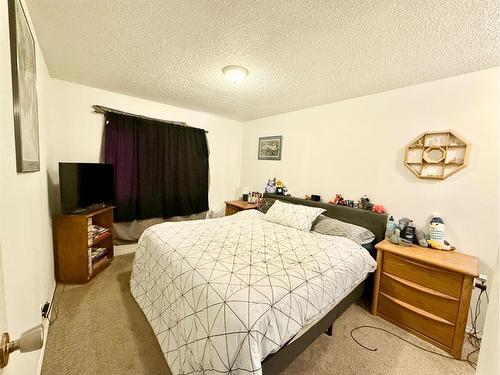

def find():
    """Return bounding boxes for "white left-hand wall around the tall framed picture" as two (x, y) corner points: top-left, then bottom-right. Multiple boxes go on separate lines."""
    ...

(0, 1), (55, 374)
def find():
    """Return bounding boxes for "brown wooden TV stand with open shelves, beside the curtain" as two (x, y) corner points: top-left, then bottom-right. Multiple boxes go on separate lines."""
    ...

(54, 207), (114, 284)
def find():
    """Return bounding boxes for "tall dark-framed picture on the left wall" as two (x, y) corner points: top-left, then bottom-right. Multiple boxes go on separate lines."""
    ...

(8, 0), (40, 173)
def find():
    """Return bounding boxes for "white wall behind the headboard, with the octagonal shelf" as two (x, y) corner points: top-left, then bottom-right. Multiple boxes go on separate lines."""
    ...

(241, 68), (500, 324)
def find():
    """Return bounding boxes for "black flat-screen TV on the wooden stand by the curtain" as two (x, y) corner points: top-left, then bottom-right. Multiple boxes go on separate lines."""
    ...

(59, 163), (114, 214)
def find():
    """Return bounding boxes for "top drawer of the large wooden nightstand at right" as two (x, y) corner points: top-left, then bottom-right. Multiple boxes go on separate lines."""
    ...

(382, 252), (463, 298)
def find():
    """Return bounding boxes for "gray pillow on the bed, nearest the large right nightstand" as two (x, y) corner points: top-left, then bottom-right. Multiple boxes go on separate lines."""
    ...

(312, 215), (375, 245)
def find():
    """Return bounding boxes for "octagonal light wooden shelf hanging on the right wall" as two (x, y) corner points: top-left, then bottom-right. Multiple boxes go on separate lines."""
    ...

(405, 130), (470, 180)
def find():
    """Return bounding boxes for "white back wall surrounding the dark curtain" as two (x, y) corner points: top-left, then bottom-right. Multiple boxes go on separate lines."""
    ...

(49, 79), (242, 214)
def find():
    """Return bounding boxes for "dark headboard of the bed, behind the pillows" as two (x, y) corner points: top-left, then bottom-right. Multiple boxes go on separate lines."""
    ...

(264, 193), (387, 243)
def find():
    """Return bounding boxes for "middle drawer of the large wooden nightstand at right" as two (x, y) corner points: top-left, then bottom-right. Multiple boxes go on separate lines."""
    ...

(380, 273), (458, 323)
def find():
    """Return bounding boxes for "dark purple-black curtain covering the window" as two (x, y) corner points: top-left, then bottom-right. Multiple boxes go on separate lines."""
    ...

(104, 113), (208, 221)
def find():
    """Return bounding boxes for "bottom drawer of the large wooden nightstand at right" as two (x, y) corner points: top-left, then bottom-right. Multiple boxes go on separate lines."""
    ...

(378, 293), (455, 346)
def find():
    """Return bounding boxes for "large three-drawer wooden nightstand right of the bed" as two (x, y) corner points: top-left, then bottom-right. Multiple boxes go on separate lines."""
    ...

(372, 240), (479, 358)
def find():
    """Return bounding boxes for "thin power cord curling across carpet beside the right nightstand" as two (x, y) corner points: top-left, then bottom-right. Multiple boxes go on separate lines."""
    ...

(351, 289), (490, 369)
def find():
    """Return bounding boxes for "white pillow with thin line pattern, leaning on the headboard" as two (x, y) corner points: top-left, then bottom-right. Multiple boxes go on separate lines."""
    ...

(263, 200), (326, 232)
